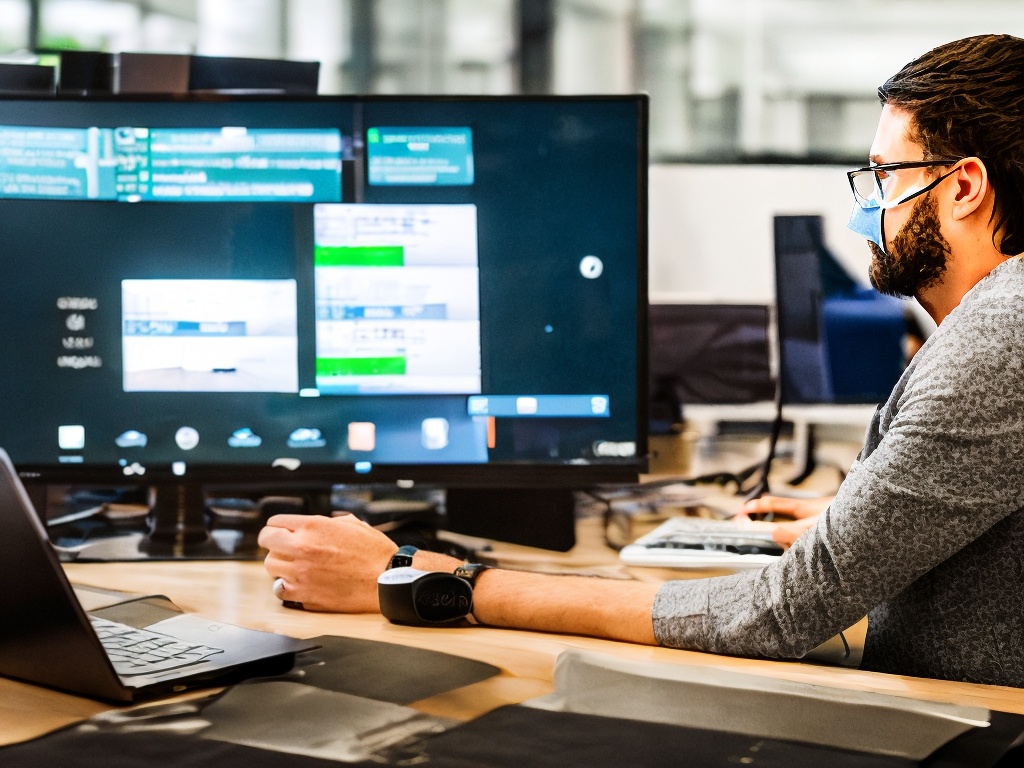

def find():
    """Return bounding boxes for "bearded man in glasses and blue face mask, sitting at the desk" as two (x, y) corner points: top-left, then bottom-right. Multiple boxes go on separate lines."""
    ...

(259, 36), (1024, 686)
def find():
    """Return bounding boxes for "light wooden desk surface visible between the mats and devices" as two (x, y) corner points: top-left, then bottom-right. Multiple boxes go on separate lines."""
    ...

(0, 518), (1024, 744)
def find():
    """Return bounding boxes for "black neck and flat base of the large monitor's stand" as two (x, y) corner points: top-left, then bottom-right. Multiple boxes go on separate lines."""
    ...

(69, 480), (261, 561)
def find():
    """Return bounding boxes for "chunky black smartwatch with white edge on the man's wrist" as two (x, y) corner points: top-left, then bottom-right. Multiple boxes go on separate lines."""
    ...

(377, 569), (473, 627)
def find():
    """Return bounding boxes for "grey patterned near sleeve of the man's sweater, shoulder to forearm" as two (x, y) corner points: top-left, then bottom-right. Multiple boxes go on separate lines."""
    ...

(652, 280), (1024, 658)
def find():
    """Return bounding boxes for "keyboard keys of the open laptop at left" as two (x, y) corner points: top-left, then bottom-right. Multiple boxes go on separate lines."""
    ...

(89, 616), (224, 677)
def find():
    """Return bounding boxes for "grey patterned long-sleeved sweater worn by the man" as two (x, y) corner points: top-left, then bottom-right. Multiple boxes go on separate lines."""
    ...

(653, 258), (1024, 687)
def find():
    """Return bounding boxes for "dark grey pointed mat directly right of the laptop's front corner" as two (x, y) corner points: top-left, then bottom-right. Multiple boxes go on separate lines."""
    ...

(298, 637), (501, 705)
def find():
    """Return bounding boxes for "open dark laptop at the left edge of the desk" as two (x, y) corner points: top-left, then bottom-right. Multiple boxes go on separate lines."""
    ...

(0, 449), (316, 702)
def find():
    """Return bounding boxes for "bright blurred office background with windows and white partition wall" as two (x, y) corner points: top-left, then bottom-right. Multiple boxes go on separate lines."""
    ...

(0, 0), (1024, 317)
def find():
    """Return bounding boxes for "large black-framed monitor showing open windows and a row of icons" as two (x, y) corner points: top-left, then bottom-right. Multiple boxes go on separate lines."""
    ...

(0, 95), (647, 556)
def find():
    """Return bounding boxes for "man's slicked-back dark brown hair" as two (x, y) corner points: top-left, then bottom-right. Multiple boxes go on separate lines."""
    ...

(879, 35), (1024, 256)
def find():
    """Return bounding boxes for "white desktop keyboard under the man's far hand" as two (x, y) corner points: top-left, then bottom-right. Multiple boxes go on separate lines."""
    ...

(618, 517), (782, 570)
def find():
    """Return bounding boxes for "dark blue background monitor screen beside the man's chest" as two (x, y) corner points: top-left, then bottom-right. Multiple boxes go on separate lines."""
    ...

(774, 215), (907, 404)
